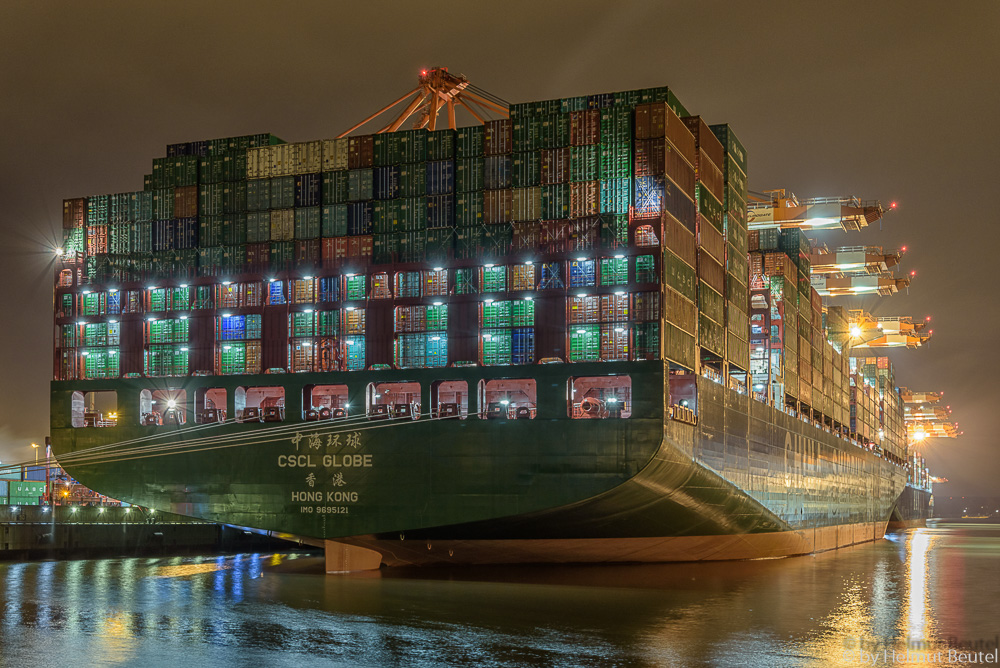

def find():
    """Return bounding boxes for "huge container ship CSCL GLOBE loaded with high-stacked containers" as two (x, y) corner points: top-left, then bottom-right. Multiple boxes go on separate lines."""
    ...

(51, 69), (929, 570)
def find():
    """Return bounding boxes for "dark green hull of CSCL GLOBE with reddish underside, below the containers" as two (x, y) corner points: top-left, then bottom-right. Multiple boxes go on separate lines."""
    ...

(52, 362), (906, 565)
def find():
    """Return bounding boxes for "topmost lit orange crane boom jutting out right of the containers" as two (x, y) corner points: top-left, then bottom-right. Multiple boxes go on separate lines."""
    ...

(747, 189), (894, 231)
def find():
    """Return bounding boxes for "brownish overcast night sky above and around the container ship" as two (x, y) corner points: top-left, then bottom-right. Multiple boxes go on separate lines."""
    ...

(0, 0), (1000, 496)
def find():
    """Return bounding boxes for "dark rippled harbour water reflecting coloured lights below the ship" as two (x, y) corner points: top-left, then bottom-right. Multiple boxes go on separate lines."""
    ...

(0, 525), (1000, 668)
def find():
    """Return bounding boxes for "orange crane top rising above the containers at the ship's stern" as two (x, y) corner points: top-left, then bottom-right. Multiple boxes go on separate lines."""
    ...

(338, 67), (510, 137)
